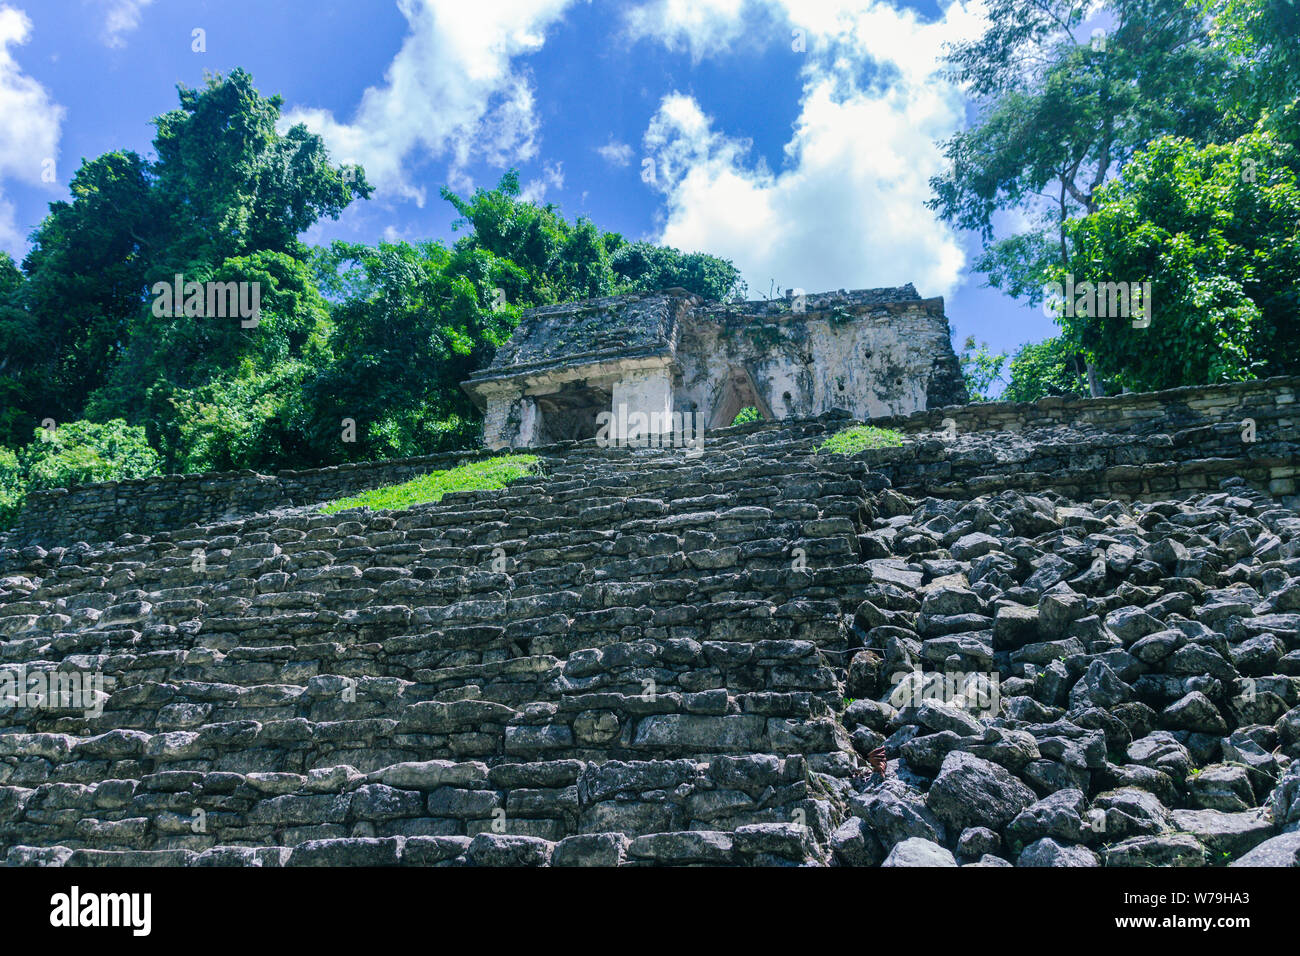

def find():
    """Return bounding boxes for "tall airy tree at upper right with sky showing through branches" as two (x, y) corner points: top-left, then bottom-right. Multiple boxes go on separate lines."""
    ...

(927, 0), (1253, 314)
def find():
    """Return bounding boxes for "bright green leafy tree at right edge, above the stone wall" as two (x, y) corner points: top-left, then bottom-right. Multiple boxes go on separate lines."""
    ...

(1058, 122), (1300, 389)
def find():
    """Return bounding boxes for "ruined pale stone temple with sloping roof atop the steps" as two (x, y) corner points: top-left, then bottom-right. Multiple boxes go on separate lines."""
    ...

(464, 284), (966, 449)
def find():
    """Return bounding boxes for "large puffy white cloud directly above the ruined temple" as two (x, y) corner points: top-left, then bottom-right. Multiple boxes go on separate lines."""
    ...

(631, 0), (983, 295)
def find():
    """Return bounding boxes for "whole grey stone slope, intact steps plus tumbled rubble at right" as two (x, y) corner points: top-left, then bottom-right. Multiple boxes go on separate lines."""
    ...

(0, 408), (1300, 866)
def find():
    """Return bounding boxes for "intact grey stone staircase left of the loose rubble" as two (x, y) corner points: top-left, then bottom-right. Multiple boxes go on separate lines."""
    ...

(0, 425), (884, 865)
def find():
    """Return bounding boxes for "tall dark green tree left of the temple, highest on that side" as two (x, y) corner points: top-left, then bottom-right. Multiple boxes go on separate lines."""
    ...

(0, 70), (373, 455)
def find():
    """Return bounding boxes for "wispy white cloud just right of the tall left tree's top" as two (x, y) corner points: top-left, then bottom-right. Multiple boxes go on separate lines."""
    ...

(285, 0), (572, 206)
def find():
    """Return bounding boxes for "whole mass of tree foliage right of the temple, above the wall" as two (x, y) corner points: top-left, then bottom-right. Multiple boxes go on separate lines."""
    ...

(928, 0), (1300, 401)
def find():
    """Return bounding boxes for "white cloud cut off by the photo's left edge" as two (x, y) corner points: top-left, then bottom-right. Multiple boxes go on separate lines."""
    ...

(0, 4), (66, 250)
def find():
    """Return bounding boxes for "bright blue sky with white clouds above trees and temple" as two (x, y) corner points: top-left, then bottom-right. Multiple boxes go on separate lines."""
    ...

(0, 0), (1053, 369)
